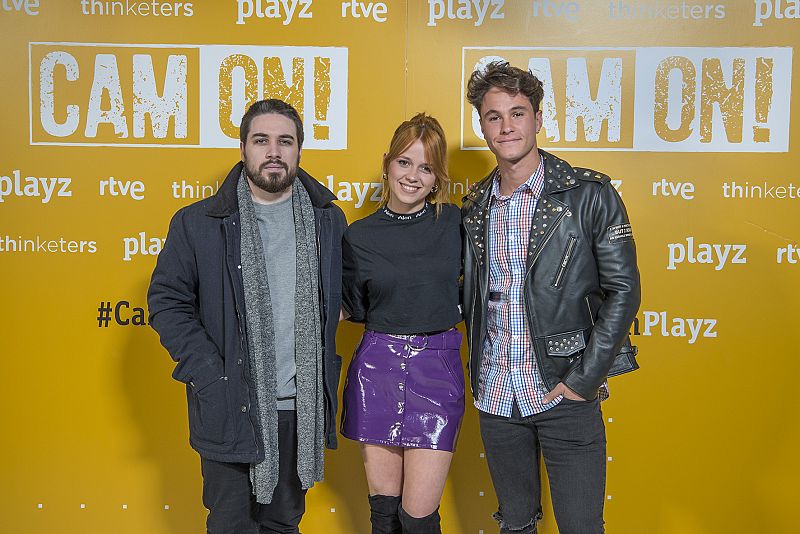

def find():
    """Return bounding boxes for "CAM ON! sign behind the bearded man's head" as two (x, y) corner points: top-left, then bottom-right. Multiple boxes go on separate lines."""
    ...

(29, 43), (348, 150)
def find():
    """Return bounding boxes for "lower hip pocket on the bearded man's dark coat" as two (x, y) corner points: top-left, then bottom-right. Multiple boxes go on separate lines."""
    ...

(189, 376), (231, 445)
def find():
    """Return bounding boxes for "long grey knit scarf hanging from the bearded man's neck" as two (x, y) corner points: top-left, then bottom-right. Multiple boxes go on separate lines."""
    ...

(237, 171), (325, 504)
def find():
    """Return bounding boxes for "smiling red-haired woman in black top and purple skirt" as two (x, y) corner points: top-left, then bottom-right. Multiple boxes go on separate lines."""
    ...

(342, 113), (464, 534)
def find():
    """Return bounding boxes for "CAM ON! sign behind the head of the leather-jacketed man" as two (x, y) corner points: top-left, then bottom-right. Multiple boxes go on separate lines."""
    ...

(461, 46), (800, 152)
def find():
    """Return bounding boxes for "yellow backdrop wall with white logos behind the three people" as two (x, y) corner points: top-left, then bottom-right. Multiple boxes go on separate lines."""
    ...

(0, 0), (800, 534)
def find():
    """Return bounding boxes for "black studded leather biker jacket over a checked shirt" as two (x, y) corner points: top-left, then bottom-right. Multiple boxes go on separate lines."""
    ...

(461, 150), (640, 399)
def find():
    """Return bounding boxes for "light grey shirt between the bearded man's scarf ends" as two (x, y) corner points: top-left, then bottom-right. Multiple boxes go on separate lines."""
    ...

(253, 197), (297, 410)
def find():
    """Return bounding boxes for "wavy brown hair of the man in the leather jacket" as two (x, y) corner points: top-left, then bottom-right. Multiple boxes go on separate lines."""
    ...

(467, 61), (544, 115)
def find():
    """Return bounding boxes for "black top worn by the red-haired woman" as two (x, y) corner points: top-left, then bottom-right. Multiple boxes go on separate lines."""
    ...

(342, 204), (462, 334)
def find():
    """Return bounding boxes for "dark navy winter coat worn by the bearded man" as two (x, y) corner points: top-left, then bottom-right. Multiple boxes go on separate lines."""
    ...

(147, 162), (347, 463)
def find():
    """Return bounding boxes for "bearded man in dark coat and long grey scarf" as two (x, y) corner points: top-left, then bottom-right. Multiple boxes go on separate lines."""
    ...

(148, 99), (347, 534)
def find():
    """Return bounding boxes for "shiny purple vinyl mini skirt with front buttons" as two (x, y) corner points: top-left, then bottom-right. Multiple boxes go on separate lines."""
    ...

(342, 328), (464, 452)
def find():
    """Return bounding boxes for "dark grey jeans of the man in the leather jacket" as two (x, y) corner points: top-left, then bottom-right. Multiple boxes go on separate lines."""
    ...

(479, 398), (606, 534)
